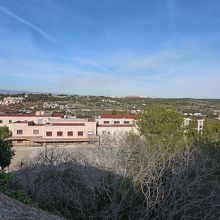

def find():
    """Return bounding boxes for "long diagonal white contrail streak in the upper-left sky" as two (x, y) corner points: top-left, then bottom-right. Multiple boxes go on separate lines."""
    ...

(0, 5), (55, 42)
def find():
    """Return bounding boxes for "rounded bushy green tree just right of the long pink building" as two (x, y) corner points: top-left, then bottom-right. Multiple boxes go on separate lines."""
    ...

(137, 105), (185, 150)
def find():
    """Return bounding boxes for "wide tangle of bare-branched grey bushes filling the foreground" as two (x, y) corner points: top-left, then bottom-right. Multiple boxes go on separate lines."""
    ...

(12, 137), (220, 220)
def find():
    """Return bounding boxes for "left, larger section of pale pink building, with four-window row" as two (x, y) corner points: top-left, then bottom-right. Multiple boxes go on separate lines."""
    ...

(0, 111), (96, 145)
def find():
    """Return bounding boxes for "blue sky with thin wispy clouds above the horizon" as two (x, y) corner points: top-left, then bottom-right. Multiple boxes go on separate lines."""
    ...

(0, 0), (220, 98)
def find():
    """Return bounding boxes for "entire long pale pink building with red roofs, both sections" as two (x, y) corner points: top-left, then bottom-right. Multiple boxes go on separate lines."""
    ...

(0, 112), (135, 145)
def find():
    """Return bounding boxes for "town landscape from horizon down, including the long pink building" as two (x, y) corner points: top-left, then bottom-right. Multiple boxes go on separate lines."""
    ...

(0, 93), (220, 146)
